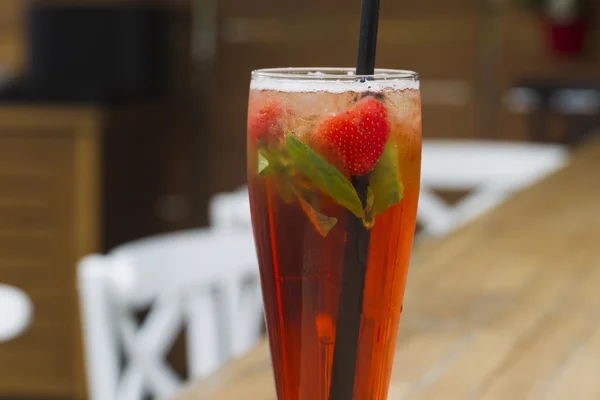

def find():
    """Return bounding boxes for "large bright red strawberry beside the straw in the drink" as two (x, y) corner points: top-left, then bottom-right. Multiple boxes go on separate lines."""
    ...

(314, 96), (390, 176)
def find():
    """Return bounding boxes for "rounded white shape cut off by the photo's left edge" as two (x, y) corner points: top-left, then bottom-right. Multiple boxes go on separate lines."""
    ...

(0, 284), (33, 342)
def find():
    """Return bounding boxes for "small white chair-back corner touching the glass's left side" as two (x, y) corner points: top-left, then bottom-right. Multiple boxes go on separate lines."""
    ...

(209, 186), (252, 229)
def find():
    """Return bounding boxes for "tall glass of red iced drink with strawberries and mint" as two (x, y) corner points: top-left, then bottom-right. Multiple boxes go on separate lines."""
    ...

(248, 68), (421, 400)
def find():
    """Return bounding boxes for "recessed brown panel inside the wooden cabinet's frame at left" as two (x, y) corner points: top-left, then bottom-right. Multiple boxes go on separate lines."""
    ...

(0, 128), (76, 396)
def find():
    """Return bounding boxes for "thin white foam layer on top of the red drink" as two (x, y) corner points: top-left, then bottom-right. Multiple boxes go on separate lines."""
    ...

(250, 73), (419, 93)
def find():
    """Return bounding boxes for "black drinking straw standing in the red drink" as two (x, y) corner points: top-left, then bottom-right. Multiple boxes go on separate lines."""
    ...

(329, 0), (379, 400)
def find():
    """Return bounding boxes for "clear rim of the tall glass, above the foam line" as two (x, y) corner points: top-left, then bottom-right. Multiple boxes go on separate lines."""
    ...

(252, 67), (419, 82)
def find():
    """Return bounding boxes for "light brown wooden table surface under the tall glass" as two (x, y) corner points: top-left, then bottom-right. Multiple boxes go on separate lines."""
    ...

(176, 140), (600, 400)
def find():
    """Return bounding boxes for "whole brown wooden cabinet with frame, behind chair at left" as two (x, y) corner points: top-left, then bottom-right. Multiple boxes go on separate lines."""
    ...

(0, 106), (102, 399)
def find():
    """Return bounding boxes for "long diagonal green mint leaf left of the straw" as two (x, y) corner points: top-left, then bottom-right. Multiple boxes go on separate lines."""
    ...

(285, 134), (365, 219)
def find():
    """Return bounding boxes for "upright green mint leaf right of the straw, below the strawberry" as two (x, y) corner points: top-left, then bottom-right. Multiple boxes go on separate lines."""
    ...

(370, 142), (404, 217)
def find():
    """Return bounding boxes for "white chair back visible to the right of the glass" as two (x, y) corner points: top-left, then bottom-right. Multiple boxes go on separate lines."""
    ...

(418, 140), (568, 236)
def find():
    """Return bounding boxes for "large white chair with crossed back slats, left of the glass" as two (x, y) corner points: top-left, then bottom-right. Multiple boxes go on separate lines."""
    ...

(78, 229), (263, 400)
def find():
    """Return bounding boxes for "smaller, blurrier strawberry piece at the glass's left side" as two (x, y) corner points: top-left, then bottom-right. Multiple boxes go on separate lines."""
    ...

(248, 100), (283, 142)
